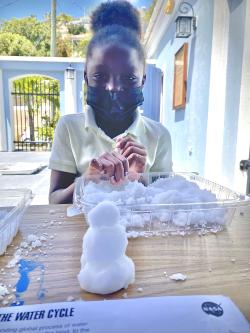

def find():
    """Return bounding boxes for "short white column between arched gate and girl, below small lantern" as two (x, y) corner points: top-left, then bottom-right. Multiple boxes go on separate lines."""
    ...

(64, 70), (77, 114)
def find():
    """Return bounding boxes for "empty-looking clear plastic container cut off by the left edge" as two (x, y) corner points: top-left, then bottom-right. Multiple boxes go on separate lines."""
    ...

(0, 189), (32, 255)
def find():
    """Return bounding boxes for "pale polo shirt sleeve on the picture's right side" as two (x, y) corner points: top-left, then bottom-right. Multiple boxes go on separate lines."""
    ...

(150, 127), (173, 172)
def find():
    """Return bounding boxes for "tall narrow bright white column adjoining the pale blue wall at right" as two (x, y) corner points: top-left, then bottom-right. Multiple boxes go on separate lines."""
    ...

(205, 0), (230, 183)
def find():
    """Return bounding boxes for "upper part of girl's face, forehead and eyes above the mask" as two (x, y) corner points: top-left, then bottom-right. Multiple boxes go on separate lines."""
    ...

(84, 45), (146, 91)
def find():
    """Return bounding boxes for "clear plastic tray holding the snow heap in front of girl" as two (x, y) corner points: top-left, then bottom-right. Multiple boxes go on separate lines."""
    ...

(74, 173), (250, 237)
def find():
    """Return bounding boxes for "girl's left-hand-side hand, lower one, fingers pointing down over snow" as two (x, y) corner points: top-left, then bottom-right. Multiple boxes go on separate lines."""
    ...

(85, 151), (128, 183)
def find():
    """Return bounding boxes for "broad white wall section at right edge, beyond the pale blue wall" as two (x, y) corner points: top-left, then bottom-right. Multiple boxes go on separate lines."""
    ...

(205, 0), (250, 193)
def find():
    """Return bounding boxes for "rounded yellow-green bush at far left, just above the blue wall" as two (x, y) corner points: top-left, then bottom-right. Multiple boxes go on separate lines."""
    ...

(0, 32), (37, 56)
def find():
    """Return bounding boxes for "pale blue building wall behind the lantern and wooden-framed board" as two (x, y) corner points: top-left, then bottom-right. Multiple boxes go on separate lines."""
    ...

(153, 0), (213, 174)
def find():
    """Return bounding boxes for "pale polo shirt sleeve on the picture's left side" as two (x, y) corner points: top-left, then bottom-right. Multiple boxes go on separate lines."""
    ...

(49, 117), (77, 174)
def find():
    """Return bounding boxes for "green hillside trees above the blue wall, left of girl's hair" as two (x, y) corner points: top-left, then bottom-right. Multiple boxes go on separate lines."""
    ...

(0, 13), (91, 57)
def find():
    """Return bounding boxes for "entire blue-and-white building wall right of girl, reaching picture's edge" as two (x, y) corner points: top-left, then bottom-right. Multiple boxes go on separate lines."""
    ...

(147, 0), (250, 193)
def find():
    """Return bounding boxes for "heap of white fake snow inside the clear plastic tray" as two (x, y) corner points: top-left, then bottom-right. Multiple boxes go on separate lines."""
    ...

(84, 175), (226, 232)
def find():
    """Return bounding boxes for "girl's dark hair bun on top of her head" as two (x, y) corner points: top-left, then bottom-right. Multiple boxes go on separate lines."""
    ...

(91, 0), (141, 37)
